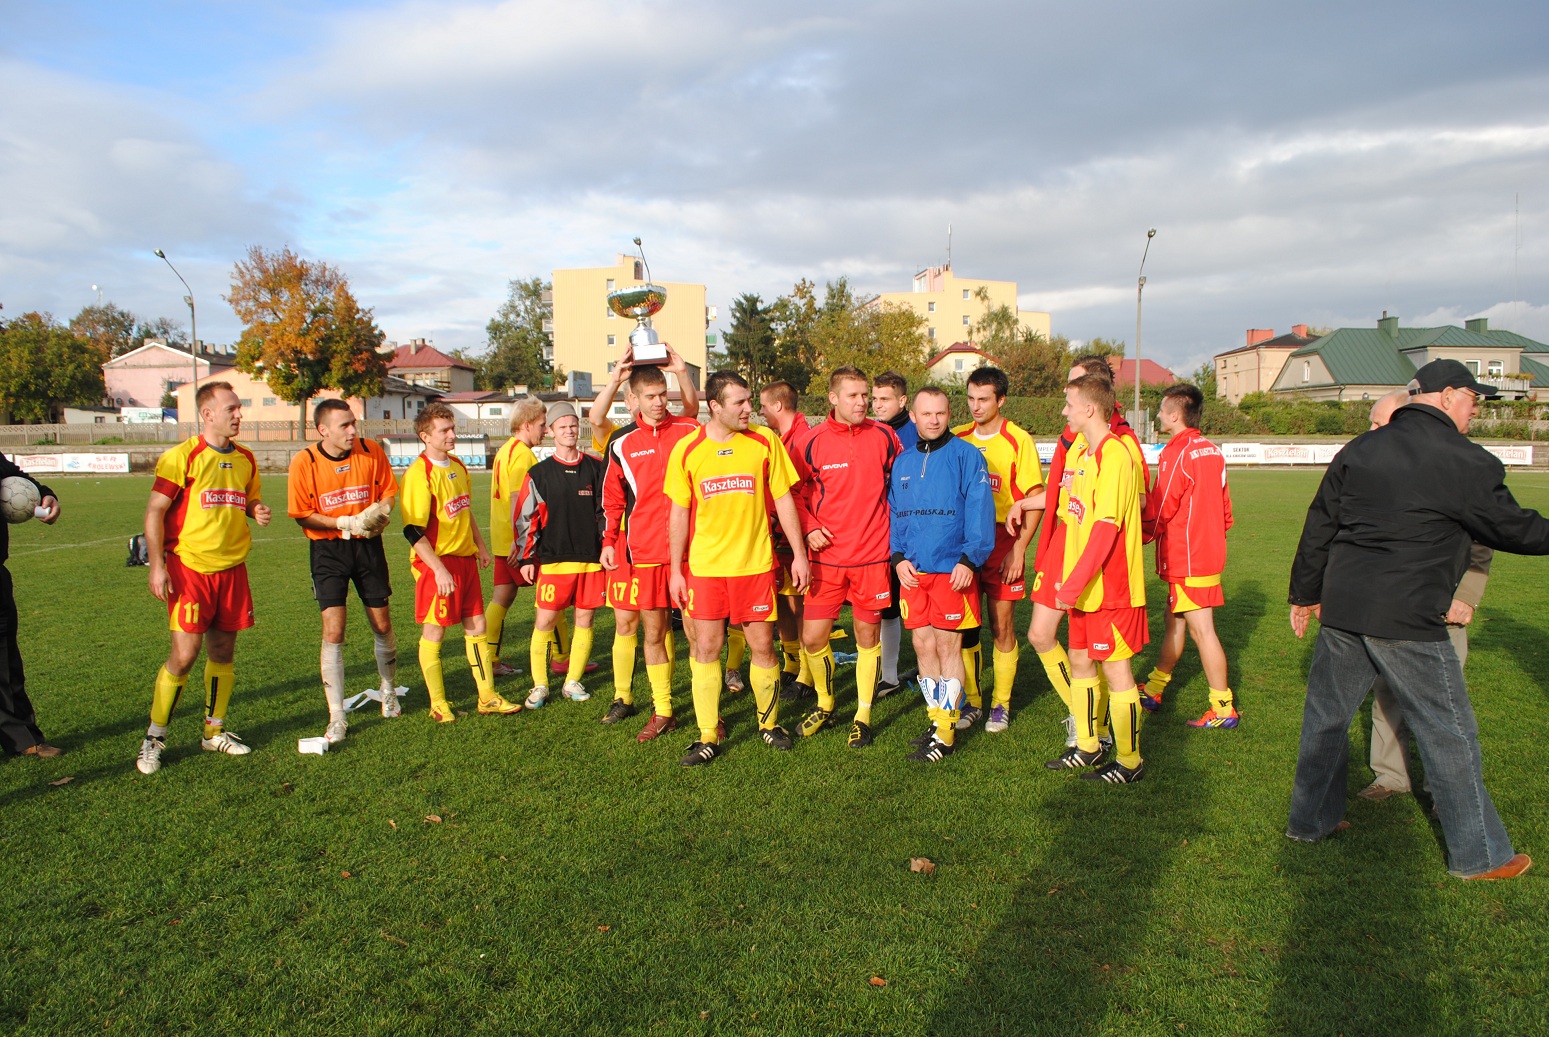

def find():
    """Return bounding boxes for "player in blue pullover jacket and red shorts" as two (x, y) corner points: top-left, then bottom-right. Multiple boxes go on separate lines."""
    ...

(888, 386), (996, 763)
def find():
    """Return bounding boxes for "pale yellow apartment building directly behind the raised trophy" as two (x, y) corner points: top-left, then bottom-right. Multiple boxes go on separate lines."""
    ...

(550, 256), (711, 384)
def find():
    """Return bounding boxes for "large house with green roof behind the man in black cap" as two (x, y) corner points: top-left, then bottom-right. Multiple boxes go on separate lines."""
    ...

(1272, 313), (1549, 400)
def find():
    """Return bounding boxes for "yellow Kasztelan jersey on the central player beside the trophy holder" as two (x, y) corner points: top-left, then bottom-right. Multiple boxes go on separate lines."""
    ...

(665, 426), (796, 577)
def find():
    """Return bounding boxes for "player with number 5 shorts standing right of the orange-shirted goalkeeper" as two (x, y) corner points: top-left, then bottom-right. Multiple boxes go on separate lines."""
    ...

(401, 403), (522, 724)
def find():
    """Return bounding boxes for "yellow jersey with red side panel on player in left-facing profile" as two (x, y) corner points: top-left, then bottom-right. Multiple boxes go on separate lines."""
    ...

(1060, 432), (1146, 612)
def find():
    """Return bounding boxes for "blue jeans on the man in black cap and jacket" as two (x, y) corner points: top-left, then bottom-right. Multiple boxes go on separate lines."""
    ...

(1286, 626), (1513, 877)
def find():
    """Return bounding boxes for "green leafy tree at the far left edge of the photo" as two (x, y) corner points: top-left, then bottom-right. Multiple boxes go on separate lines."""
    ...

(0, 313), (105, 422)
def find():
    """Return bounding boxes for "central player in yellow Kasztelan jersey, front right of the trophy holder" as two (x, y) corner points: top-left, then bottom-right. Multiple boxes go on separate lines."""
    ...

(666, 370), (809, 767)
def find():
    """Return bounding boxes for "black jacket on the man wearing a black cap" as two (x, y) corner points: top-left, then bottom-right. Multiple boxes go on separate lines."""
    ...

(1290, 403), (1549, 640)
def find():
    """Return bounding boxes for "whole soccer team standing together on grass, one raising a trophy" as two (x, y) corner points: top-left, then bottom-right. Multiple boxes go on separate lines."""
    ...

(136, 350), (1239, 784)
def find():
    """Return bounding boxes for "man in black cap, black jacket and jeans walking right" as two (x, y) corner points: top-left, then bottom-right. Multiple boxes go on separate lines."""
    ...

(1286, 360), (1549, 879)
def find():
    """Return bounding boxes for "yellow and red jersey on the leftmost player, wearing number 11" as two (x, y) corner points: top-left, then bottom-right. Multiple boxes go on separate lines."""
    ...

(152, 436), (259, 572)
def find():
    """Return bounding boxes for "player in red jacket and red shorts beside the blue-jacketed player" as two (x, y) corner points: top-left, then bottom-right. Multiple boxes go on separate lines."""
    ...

(793, 367), (902, 749)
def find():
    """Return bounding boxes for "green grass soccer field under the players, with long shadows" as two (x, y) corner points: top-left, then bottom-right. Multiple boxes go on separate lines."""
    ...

(0, 471), (1549, 1035)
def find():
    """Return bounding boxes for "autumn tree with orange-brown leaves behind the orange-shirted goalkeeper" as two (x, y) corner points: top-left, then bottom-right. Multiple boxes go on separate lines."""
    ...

(226, 245), (387, 425)
